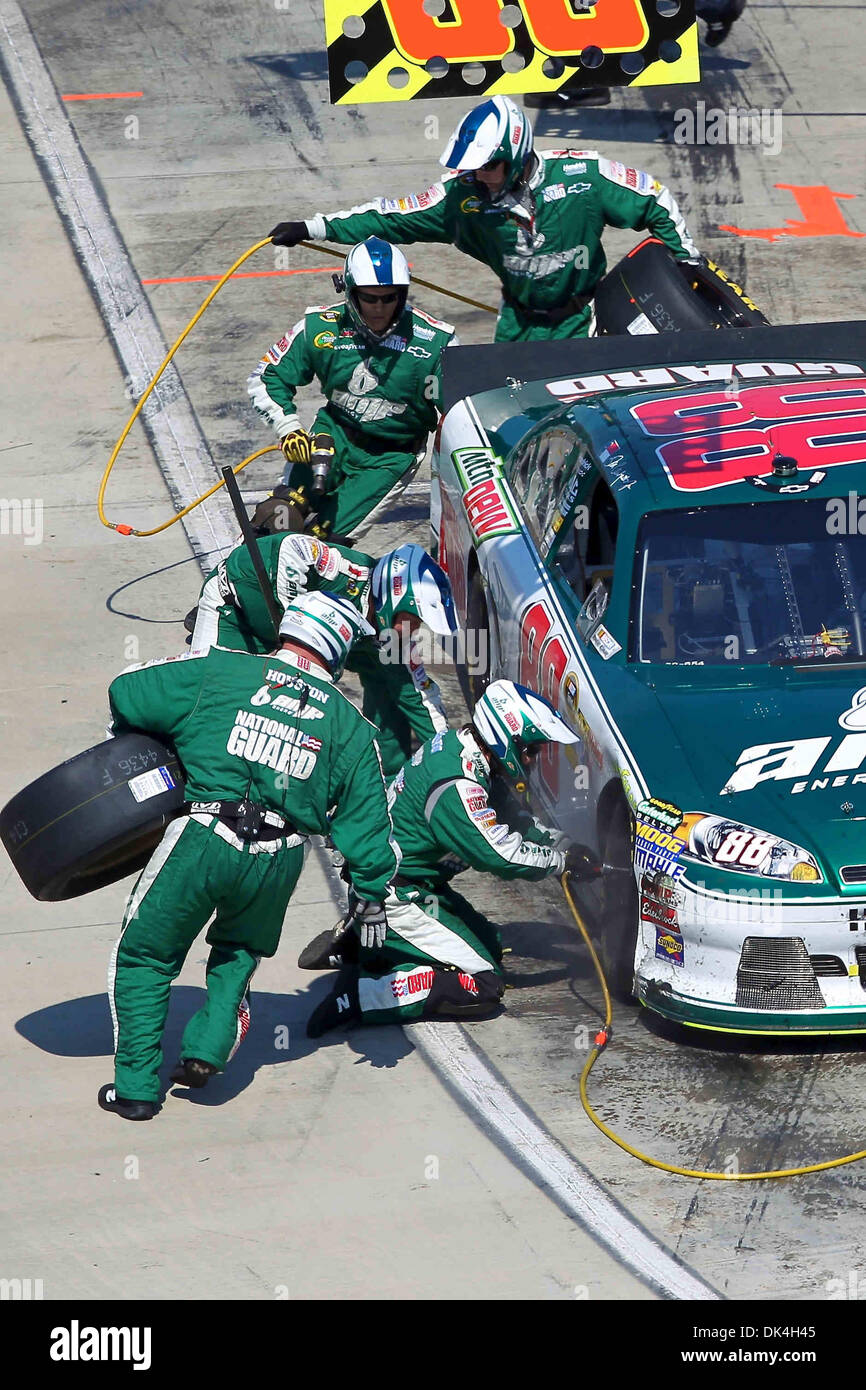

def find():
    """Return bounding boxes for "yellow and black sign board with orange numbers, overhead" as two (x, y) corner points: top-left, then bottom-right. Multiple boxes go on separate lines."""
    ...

(324, 0), (701, 106)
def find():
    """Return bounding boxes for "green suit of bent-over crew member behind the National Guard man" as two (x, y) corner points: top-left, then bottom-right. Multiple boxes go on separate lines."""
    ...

(190, 532), (448, 777)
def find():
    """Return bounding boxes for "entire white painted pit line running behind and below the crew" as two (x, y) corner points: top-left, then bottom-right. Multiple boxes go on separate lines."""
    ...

(0, 0), (719, 1300)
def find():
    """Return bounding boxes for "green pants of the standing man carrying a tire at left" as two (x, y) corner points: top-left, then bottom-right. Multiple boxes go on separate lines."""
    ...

(108, 816), (303, 1101)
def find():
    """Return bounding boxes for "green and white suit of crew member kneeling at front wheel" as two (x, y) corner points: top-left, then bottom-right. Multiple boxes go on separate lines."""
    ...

(357, 728), (566, 1023)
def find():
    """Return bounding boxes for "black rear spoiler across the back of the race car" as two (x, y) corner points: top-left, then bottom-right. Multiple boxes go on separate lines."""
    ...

(442, 320), (866, 411)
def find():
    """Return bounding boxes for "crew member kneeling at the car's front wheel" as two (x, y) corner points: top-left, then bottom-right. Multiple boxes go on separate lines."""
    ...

(297, 681), (591, 1037)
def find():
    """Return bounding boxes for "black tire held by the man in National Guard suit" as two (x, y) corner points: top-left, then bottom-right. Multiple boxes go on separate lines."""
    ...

(0, 734), (183, 902)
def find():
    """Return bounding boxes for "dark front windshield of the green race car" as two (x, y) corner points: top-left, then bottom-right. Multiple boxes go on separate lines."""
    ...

(631, 499), (866, 666)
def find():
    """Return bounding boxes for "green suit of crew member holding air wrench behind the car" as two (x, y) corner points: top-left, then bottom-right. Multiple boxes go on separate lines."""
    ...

(247, 304), (457, 535)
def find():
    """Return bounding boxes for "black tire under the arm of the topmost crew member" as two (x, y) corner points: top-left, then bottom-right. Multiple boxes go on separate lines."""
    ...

(595, 238), (767, 334)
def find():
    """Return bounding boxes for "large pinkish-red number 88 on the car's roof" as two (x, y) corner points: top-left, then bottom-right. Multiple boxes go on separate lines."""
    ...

(631, 378), (866, 492)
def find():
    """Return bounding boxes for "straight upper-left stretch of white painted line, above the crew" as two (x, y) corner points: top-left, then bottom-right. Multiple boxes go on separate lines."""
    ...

(0, 0), (238, 569)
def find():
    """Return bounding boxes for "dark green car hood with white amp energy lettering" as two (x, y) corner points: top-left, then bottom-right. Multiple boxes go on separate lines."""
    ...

(619, 666), (866, 876)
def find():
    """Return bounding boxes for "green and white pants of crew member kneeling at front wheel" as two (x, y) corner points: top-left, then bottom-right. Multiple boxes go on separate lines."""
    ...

(357, 885), (505, 1023)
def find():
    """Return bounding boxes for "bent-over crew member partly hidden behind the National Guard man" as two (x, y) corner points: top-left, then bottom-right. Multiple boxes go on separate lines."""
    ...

(190, 534), (457, 777)
